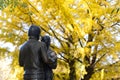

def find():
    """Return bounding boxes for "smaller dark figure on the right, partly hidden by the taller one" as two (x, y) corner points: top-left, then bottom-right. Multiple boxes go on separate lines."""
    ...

(41, 36), (57, 80)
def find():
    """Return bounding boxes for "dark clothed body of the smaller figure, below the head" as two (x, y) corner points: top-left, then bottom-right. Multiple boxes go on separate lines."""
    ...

(45, 48), (57, 80)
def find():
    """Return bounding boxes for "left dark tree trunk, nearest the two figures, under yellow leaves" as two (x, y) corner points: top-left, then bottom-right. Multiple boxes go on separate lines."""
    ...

(69, 60), (76, 80)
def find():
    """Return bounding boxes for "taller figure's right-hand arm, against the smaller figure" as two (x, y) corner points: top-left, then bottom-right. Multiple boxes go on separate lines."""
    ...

(40, 42), (50, 63)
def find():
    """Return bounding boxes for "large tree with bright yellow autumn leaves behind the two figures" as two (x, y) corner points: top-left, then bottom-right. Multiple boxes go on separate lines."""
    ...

(0, 0), (120, 80)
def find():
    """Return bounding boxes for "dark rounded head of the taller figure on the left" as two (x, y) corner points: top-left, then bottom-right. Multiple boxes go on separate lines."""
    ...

(28, 25), (41, 39)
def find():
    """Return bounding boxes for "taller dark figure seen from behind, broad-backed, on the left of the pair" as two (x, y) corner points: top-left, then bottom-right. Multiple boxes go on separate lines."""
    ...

(19, 25), (49, 80)
